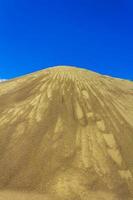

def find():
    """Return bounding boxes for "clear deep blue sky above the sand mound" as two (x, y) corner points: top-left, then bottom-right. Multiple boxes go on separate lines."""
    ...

(0, 0), (133, 80)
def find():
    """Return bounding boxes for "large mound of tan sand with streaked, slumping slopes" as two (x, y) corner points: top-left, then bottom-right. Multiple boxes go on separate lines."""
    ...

(0, 67), (133, 200)
